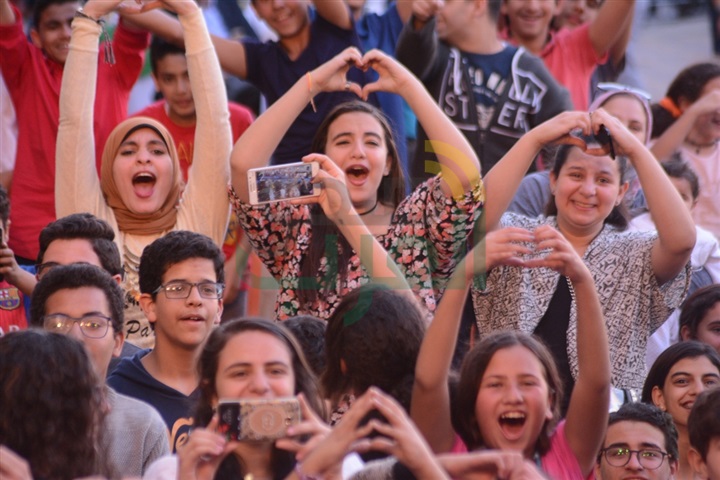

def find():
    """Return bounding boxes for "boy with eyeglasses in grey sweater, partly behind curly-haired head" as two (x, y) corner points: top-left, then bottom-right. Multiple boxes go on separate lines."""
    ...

(30, 263), (169, 478)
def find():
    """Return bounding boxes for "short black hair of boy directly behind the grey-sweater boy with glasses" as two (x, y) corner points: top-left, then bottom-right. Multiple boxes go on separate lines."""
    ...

(37, 213), (124, 276)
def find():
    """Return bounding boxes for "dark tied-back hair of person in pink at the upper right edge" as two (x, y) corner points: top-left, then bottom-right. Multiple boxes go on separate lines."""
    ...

(651, 62), (720, 138)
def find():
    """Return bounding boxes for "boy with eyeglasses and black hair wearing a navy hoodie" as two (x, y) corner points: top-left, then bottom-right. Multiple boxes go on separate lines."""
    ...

(108, 230), (224, 451)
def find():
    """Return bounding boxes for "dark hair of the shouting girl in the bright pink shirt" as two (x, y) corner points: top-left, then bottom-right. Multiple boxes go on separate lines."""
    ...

(454, 331), (563, 455)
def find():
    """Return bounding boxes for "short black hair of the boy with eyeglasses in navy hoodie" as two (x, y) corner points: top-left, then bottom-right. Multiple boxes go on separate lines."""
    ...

(139, 230), (225, 298)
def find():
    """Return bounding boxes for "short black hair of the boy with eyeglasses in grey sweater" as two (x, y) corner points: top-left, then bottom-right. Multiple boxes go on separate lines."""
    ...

(30, 263), (125, 333)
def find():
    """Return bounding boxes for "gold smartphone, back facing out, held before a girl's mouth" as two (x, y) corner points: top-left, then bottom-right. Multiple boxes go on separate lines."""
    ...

(218, 397), (302, 442)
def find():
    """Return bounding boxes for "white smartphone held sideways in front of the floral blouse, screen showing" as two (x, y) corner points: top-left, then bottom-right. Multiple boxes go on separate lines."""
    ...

(248, 162), (320, 205)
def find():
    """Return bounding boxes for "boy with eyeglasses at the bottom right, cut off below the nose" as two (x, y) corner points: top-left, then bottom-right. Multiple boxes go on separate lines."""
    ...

(595, 403), (678, 480)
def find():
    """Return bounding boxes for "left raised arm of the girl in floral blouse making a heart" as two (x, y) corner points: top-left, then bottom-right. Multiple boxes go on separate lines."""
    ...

(230, 47), (362, 202)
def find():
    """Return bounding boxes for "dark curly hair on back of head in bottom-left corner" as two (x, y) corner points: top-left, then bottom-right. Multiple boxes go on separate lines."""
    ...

(0, 329), (106, 480)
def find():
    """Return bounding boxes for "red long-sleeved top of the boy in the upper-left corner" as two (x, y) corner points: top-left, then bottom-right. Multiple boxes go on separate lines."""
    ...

(0, 7), (150, 259)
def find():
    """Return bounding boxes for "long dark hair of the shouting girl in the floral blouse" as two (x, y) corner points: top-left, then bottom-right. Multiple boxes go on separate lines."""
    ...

(298, 101), (405, 305)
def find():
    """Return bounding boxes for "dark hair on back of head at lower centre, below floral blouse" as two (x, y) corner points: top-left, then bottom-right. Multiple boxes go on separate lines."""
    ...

(321, 283), (425, 410)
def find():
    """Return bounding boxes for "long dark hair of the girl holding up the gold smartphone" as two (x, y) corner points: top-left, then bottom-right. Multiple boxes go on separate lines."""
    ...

(194, 318), (327, 480)
